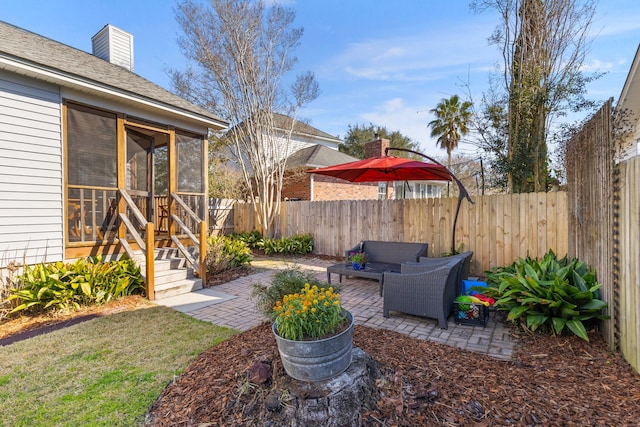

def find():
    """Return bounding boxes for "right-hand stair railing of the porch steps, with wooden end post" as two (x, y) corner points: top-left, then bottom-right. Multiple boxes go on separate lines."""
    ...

(171, 193), (207, 283)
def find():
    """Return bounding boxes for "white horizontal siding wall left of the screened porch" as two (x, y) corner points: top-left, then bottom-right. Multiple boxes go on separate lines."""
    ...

(0, 71), (64, 263)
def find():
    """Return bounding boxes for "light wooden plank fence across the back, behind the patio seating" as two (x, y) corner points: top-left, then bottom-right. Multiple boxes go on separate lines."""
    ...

(234, 192), (568, 275)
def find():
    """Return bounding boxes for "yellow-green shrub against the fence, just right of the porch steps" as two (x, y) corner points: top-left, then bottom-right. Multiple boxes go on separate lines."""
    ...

(205, 235), (252, 274)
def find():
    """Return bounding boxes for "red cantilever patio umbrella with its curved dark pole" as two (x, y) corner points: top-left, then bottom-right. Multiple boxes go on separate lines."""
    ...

(307, 148), (473, 253)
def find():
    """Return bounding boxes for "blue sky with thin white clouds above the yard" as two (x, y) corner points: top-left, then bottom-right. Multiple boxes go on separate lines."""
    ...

(0, 0), (640, 156)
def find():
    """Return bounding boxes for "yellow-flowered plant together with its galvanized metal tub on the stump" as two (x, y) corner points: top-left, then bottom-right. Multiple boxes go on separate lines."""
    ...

(272, 284), (353, 381)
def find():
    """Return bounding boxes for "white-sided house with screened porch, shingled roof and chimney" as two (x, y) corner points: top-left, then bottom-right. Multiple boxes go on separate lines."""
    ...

(0, 21), (228, 270)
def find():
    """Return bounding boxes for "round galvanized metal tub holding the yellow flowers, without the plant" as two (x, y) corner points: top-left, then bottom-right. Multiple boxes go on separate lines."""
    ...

(271, 311), (353, 381)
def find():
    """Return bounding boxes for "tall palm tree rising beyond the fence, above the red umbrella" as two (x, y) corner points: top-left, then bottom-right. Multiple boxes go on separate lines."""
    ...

(429, 95), (471, 166)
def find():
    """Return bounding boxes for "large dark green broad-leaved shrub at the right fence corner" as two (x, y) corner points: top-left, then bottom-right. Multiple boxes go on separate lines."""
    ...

(483, 250), (609, 341)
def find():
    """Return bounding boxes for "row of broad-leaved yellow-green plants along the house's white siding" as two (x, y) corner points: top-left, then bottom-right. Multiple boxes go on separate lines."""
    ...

(8, 256), (144, 313)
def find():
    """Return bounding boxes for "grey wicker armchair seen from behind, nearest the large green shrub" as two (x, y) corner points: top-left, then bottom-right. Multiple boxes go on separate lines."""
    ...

(382, 257), (463, 329)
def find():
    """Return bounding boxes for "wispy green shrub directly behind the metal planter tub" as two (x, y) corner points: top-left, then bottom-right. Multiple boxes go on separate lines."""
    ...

(251, 266), (340, 320)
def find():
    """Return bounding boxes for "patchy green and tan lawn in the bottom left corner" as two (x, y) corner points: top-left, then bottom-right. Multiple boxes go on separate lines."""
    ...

(0, 306), (237, 427)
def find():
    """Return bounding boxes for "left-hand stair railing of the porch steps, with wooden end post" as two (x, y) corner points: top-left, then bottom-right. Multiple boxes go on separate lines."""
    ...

(118, 190), (155, 300)
